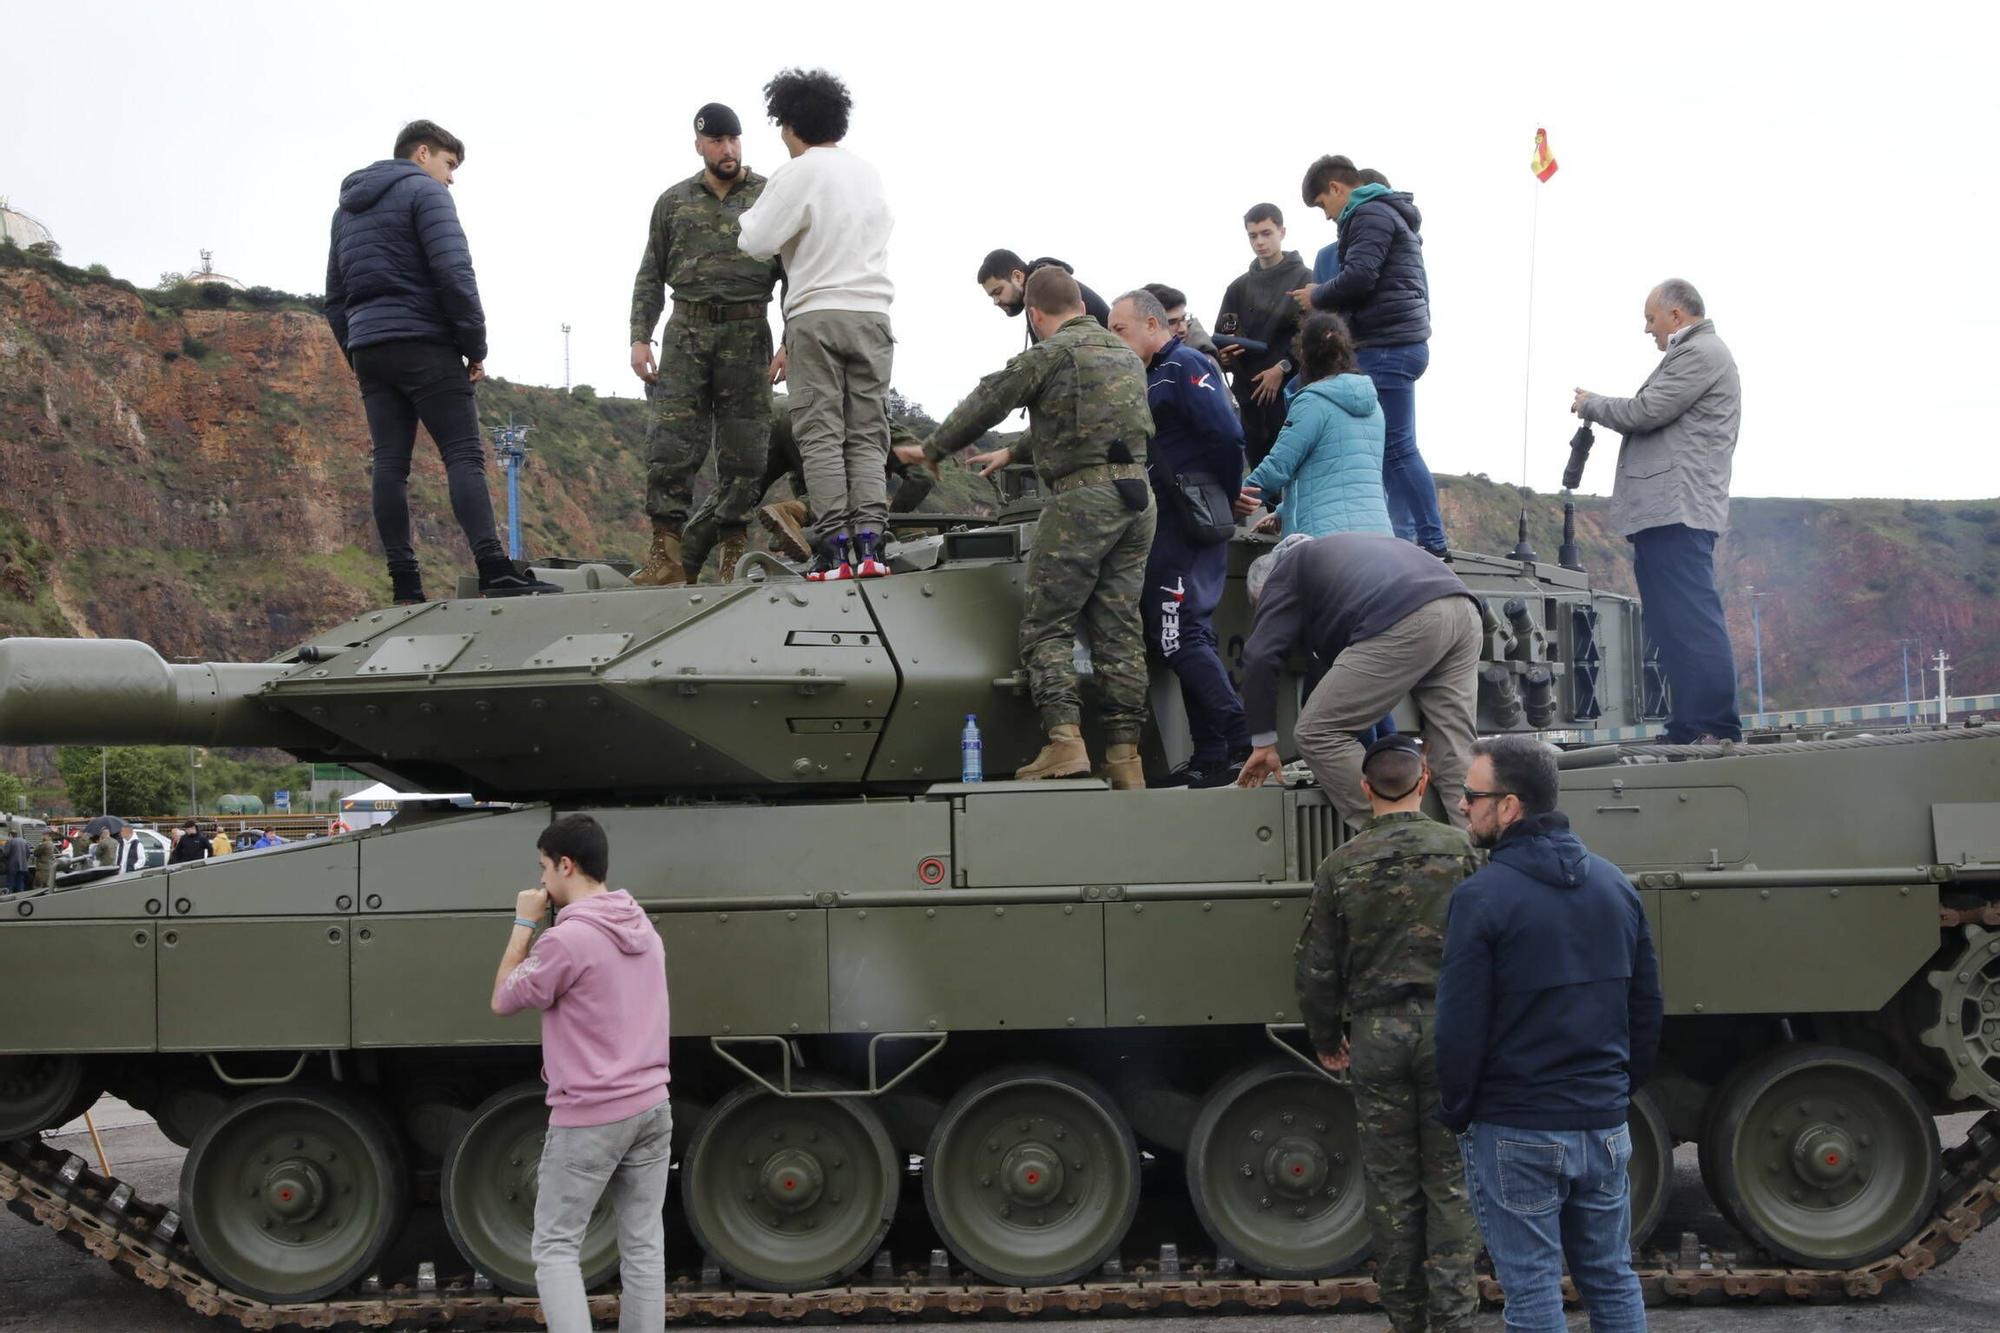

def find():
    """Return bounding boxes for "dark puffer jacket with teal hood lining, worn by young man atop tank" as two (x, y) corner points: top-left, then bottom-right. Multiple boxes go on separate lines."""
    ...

(1312, 184), (1430, 346)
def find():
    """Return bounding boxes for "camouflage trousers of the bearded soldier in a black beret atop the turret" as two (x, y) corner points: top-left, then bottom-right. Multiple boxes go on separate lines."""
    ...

(646, 312), (770, 530)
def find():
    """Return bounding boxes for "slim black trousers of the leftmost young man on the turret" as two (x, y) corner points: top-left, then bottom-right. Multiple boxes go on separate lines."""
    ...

(352, 340), (506, 572)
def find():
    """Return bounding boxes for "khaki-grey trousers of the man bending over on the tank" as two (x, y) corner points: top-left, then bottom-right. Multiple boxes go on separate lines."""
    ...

(1292, 596), (1480, 829)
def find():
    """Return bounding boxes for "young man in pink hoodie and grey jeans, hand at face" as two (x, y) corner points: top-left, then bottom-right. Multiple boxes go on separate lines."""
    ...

(494, 815), (674, 1333)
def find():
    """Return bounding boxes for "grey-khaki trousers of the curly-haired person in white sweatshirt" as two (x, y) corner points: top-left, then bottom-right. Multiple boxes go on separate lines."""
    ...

(784, 310), (896, 542)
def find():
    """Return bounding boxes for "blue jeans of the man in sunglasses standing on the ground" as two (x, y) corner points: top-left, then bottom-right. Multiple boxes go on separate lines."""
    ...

(1458, 1121), (1646, 1333)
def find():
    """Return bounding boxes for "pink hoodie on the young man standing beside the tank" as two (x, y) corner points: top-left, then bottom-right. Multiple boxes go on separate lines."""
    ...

(494, 889), (668, 1127)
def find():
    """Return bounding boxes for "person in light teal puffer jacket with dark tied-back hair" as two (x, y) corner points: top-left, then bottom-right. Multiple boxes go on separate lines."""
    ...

(1236, 314), (1394, 536)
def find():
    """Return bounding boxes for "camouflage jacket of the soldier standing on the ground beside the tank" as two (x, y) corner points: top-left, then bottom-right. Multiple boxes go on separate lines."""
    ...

(1292, 813), (1480, 1051)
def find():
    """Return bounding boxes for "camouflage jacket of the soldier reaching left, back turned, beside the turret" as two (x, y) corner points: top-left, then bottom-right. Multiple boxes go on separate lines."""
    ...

(924, 314), (1152, 486)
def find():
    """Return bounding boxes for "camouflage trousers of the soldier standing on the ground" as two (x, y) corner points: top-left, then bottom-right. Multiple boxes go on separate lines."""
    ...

(1348, 1001), (1480, 1333)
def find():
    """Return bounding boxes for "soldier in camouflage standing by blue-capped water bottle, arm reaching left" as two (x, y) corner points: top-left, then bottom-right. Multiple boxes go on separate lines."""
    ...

(896, 266), (1158, 791)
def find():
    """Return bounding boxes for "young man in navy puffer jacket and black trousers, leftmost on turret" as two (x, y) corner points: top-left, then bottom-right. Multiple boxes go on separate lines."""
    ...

(326, 120), (556, 604)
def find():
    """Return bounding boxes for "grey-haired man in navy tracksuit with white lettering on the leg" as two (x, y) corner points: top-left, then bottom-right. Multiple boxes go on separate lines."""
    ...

(1110, 288), (1250, 787)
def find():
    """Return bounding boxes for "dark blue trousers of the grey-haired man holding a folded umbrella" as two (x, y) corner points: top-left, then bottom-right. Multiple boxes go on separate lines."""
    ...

(1630, 522), (1744, 745)
